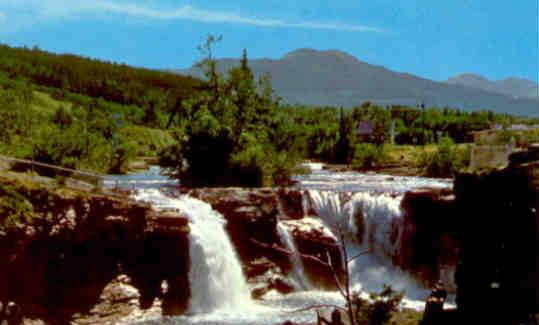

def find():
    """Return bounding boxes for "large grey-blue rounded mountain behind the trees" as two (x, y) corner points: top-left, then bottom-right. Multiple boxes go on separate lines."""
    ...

(176, 49), (539, 116)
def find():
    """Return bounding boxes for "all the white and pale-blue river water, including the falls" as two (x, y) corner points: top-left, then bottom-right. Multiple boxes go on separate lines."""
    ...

(105, 164), (452, 325)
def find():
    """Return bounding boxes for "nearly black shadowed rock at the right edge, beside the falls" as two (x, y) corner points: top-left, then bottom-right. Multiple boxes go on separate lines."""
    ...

(454, 148), (539, 324)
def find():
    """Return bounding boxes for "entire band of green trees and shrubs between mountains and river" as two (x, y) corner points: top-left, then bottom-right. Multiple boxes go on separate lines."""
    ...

(0, 41), (538, 181)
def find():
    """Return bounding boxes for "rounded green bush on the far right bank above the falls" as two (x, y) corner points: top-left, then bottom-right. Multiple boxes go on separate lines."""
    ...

(418, 137), (470, 177)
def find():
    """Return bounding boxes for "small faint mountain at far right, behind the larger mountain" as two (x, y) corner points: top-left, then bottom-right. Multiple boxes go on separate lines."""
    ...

(446, 73), (539, 99)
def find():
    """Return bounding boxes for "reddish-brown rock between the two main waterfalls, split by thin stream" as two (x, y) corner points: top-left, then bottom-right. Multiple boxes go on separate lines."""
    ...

(189, 188), (340, 296)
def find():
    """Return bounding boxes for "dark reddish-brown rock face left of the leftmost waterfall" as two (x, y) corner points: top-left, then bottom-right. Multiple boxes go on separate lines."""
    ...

(0, 181), (189, 324)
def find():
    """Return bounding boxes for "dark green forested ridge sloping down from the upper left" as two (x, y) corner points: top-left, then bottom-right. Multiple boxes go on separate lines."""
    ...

(0, 45), (204, 106)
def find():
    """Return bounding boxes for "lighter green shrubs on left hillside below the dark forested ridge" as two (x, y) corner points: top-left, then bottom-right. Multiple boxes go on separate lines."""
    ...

(0, 75), (172, 173)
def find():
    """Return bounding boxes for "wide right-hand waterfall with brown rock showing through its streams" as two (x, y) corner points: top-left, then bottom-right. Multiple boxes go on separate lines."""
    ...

(306, 190), (428, 304)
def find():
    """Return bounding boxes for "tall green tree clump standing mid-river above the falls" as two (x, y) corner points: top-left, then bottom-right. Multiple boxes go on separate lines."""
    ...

(160, 42), (298, 186)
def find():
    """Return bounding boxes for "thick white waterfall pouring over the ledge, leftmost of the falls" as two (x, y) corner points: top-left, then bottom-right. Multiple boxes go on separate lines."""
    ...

(135, 189), (251, 314)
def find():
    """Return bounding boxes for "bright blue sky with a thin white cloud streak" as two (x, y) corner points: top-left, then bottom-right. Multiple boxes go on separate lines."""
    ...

(0, 0), (539, 81)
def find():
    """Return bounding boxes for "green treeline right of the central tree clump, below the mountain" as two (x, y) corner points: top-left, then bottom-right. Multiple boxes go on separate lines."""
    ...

(284, 102), (537, 163)
